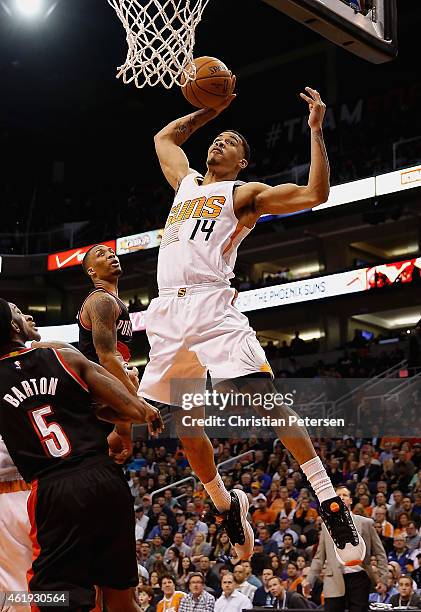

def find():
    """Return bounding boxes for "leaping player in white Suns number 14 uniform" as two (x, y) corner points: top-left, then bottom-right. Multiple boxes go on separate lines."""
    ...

(139, 87), (365, 565)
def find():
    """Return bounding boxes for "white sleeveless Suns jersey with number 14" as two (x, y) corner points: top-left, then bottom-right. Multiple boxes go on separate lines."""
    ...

(158, 172), (251, 289)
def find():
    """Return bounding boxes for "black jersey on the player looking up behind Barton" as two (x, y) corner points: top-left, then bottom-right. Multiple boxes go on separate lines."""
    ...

(77, 289), (133, 363)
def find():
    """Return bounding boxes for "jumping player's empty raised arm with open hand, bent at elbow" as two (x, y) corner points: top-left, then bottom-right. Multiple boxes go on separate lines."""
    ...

(241, 87), (330, 218)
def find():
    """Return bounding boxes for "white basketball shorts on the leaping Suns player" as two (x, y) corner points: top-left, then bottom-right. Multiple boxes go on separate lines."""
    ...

(139, 285), (272, 405)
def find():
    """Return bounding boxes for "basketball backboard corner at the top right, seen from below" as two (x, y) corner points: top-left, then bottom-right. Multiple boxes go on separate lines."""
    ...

(264, 0), (397, 64)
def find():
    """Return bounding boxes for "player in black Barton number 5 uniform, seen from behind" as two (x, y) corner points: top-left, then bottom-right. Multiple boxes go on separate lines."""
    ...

(0, 299), (162, 612)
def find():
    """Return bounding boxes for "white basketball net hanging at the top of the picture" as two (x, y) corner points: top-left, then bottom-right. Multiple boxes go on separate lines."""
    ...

(108, 0), (209, 89)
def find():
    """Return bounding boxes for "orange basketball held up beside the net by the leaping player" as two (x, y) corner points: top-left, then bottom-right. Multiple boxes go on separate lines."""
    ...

(181, 56), (234, 108)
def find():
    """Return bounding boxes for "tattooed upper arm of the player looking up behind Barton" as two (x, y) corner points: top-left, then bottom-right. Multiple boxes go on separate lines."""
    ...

(89, 295), (117, 355)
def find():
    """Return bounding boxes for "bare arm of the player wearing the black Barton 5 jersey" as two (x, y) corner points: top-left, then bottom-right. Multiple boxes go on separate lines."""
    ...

(54, 349), (163, 433)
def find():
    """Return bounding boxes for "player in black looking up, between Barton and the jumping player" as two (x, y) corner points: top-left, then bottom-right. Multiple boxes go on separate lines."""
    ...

(77, 244), (138, 463)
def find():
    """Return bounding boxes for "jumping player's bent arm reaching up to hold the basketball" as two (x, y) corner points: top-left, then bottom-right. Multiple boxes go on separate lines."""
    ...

(154, 87), (235, 191)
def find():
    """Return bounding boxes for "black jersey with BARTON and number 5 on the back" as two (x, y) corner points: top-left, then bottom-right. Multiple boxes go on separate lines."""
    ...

(0, 348), (108, 482)
